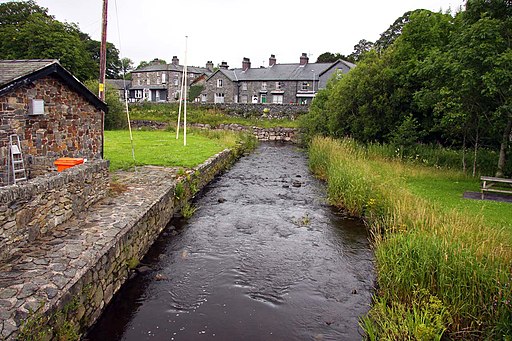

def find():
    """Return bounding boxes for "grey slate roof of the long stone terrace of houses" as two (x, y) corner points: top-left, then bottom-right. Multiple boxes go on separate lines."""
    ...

(210, 60), (355, 82)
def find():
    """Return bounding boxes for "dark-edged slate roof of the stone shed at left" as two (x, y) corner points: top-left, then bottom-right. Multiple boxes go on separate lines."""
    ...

(0, 59), (108, 113)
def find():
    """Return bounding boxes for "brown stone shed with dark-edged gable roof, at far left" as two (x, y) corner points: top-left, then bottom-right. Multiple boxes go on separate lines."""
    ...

(0, 60), (107, 186)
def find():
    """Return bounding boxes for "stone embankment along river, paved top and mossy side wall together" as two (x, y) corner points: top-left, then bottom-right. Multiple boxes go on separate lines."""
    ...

(0, 149), (241, 340)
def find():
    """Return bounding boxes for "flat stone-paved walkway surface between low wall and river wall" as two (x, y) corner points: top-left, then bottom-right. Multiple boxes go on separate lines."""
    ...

(0, 167), (180, 340)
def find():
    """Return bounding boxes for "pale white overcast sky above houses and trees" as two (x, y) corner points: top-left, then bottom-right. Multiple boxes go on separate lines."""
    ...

(22, 0), (464, 67)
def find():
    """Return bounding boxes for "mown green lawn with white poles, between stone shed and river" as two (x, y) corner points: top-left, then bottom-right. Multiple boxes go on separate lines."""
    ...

(105, 130), (237, 171)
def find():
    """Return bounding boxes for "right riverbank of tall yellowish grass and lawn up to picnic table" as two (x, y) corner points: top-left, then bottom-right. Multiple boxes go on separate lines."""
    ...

(310, 138), (512, 340)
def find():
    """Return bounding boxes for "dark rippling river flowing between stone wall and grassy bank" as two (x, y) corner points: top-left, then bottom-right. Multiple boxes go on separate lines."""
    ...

(86, 143), (374, 341)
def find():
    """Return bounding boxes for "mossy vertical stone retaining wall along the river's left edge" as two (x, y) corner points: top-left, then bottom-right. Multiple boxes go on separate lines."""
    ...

(26, 149), (241, 336)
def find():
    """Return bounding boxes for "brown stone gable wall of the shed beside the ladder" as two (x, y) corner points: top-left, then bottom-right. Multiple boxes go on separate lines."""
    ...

(0, 76), (103, 186)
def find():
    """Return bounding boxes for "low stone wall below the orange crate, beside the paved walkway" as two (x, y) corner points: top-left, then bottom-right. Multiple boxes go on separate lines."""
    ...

(0, 160), (109, 260)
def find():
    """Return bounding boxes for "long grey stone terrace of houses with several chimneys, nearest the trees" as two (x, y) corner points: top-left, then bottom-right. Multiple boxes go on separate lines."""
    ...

(201, 53), (355, 104)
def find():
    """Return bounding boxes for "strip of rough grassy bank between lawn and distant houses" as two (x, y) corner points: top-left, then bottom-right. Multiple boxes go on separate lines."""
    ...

(130, 103), (299, 128)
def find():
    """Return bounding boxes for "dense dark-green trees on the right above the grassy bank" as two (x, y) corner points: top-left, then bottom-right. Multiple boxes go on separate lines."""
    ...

(303, 0), (512, 177)
